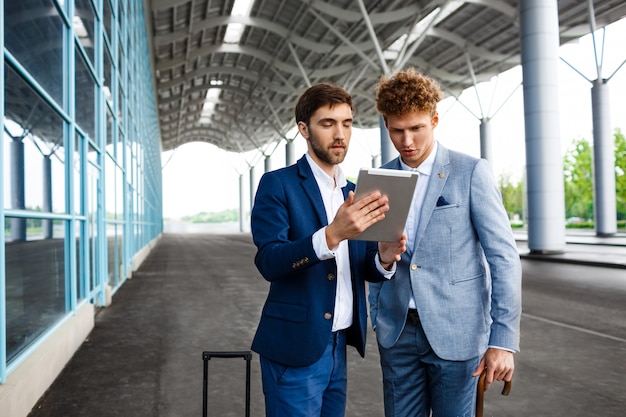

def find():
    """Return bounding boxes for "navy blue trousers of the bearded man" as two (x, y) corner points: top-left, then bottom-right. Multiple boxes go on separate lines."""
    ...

(260, 332), (348, 417)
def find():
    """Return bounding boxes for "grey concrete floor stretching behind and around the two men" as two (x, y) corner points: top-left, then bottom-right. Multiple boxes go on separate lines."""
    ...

(29, 233), (626, 417)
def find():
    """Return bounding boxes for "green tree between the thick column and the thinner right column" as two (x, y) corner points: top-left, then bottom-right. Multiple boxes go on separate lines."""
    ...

(563, 138), (593, 219)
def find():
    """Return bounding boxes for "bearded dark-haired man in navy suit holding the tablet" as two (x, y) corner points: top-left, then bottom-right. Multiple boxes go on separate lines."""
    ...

(251, 83), (406, 417)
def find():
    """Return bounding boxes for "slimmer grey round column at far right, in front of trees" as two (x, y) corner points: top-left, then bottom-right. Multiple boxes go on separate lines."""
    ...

(591, 79), (617, 236)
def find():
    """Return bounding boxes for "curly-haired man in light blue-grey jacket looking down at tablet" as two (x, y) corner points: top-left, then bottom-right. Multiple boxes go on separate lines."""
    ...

(369, 68), (521, 417)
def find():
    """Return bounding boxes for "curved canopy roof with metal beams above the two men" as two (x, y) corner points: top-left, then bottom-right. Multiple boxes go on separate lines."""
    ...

(150, 0), (626, 152)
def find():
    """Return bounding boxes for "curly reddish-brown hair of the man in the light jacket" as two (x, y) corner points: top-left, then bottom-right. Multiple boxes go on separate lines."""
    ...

(376, 68), (443, 118)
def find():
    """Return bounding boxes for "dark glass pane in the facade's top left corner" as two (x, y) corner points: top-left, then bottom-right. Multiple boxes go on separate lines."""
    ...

(4, 0), (63, 105)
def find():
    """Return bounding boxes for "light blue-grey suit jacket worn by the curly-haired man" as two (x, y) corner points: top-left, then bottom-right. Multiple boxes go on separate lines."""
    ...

(369, 144), (521, 360)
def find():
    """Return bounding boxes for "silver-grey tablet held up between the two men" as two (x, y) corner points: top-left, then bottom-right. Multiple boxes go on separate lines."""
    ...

(352, 168), (418, 242)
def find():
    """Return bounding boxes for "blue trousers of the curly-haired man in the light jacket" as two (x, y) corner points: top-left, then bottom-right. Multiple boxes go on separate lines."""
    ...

(378, 321), (480, 417)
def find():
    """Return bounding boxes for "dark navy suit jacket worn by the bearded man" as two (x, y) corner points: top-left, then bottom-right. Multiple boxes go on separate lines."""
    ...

(251, 157), (384, 366)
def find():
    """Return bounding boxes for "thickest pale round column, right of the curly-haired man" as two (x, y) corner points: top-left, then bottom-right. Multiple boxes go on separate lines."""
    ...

(519, 0), (565, 253)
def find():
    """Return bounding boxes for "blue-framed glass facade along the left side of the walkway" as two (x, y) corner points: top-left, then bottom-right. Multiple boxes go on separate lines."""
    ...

(0, 0), (163, 383)
